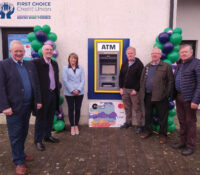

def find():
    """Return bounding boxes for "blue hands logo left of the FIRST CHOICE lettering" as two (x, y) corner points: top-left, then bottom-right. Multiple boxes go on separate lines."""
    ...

(0, 2), (15, 19)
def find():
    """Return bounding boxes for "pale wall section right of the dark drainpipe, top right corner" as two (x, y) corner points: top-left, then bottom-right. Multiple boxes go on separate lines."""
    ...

(176, 0), (200, 58)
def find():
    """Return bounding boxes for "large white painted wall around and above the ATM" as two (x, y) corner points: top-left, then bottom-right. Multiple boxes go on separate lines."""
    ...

(0, 0), (170, 124)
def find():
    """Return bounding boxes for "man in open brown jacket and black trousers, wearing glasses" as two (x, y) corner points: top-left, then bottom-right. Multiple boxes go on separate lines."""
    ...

(140, 48), (174, 143)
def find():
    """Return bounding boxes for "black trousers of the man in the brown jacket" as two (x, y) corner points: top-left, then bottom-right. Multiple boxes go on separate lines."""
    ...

(145, 94), (169, 136)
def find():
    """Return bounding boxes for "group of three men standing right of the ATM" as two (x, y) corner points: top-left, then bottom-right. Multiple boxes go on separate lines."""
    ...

(119, 44), (200, 156)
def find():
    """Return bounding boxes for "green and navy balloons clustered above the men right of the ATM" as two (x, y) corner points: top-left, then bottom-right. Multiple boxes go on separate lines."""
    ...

(153, 28), (182, 65)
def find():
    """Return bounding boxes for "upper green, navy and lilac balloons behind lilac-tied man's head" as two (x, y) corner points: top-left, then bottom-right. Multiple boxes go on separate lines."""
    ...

(27, 25), (58, 61)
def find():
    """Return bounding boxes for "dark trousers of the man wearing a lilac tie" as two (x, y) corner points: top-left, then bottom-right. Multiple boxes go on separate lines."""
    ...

(34, 91), (56, 143)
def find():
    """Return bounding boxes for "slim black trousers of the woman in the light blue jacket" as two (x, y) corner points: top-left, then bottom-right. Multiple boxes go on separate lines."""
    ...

(65, 95), (83, 126)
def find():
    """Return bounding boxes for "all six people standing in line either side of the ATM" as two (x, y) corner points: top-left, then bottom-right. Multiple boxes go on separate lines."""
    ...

(0, 40), (200, 174)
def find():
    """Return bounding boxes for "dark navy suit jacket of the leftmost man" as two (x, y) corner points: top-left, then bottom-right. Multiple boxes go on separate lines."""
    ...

(0, 58), (41, 114)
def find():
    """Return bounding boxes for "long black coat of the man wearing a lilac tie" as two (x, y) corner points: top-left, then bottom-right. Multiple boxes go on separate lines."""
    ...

(33, 58), (60, 116)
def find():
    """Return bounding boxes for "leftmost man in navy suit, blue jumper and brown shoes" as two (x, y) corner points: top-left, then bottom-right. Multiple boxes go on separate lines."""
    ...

(0, 40), (42, 174)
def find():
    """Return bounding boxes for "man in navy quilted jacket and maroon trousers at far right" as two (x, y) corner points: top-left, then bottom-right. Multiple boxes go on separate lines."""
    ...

(173, 44), (200, 156)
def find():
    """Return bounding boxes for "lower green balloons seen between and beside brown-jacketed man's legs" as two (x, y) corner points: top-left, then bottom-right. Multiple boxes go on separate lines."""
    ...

(152, 99), (176, 132)
